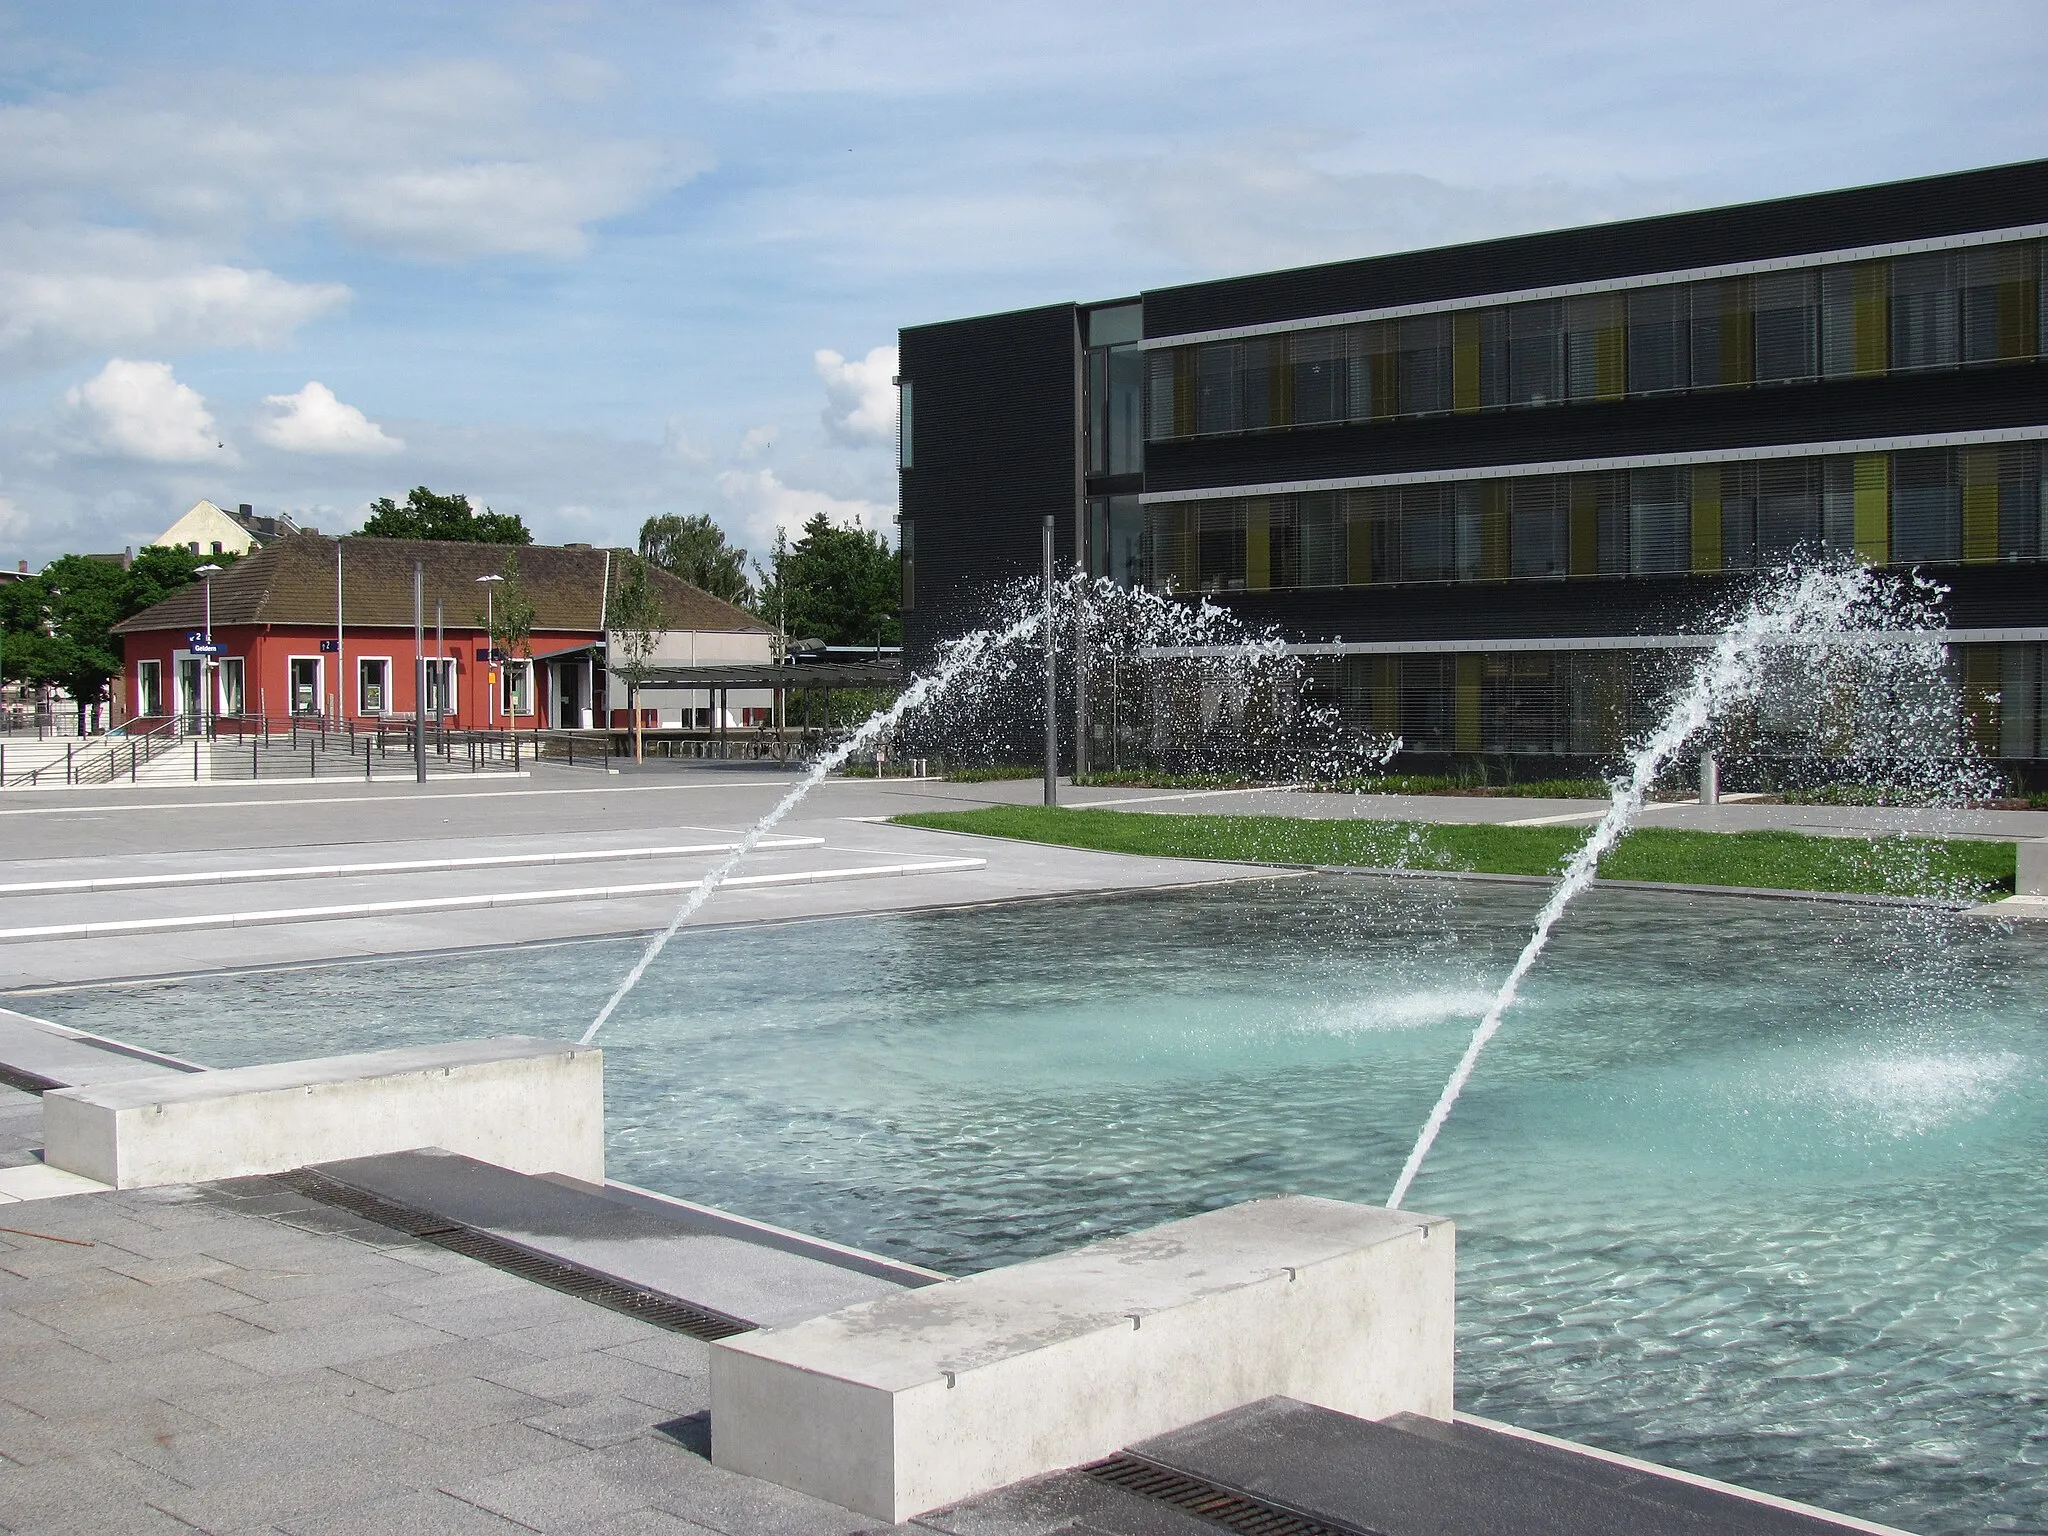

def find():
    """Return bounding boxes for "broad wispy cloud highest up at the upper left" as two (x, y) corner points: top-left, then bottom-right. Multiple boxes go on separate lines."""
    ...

(0, 61), (709, 262)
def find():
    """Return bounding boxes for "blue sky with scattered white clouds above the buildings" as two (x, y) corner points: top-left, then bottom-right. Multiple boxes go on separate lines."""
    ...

(0, 0), (2048, 569)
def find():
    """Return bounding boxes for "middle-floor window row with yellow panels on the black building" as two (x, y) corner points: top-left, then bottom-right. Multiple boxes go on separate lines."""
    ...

(1138, 442), (2048, 592)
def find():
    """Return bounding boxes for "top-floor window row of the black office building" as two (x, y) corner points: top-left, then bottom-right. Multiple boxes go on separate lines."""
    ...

(1145, 240), (2048, 442)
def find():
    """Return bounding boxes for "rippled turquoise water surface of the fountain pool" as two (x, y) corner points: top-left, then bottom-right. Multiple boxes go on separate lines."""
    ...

(16, 879), (2048, 1532)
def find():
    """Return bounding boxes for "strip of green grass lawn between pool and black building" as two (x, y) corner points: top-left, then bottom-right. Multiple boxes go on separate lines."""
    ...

(895, 805), (2013, 897)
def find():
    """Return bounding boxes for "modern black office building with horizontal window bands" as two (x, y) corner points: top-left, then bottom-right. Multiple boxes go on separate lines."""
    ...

(901, 162), (2048, 776)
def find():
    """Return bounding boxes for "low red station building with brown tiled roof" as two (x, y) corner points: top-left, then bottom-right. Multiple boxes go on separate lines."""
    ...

(115, 532), (770, 729)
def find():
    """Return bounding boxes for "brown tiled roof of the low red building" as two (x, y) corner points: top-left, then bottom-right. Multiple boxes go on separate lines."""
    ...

(115, 532), (768, 635)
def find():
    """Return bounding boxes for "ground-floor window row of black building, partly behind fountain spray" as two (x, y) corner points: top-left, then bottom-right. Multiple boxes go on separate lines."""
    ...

(1311, 643), (2048, 760)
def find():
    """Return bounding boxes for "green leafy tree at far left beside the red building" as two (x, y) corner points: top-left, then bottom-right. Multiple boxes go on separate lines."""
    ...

(0, 545), (236, 731)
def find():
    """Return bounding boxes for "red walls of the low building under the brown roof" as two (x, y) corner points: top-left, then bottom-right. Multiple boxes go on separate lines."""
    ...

(119, 625), (602, 729)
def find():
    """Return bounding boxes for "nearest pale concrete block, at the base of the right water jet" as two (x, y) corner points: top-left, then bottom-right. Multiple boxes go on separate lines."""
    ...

(711, 1196), (1456, 1524)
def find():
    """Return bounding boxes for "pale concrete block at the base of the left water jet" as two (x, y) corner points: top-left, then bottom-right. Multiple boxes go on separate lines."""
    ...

(43, 1034), (604, 1190)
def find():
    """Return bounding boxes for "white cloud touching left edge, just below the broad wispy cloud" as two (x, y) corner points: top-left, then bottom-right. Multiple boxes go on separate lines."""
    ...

(0, 225), (350, 371)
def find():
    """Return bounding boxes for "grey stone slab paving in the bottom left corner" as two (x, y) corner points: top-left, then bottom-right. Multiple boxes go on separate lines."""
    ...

(0, 1180), (872, 1536)
